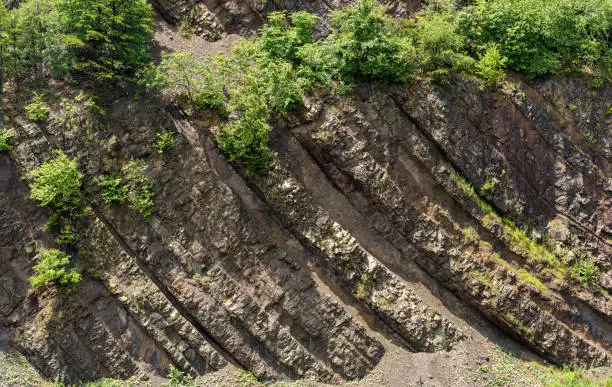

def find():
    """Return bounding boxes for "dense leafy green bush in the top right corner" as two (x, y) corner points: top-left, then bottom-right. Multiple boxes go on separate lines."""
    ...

(462, 0), (612, 77)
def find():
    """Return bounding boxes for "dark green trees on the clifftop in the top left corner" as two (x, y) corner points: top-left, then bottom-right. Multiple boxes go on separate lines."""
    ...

(0, 0), (152, 86)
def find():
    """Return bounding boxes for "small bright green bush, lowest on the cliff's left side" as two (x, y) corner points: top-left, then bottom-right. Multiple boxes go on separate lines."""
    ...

(30, 249), (81, 290)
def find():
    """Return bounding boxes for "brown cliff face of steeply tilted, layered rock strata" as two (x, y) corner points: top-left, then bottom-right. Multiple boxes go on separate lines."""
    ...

(0, 1), (612, 385)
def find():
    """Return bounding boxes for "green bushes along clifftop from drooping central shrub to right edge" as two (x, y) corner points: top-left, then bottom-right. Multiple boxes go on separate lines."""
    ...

(148, 0), (612, 175)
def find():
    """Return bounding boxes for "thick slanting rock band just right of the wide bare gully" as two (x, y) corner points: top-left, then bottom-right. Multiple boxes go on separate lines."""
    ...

(284, 84), (610, 364)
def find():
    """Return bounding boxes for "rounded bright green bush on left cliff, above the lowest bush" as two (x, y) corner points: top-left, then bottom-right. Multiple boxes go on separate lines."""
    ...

(30, 150), (83, 221)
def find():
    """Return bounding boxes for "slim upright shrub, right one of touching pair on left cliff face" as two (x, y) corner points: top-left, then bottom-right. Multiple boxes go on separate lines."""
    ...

(122, 159), (154, 219)
